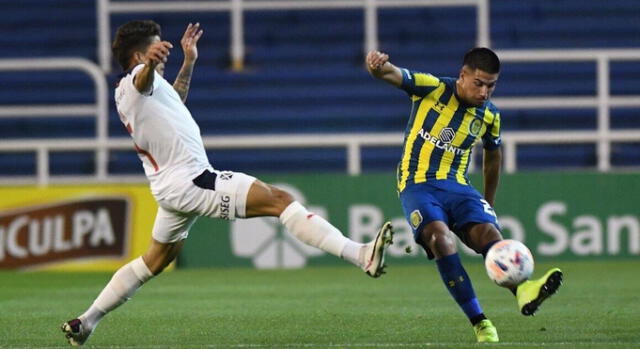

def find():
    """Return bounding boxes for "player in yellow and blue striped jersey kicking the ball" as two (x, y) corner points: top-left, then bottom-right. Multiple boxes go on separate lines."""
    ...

(366, 48), (562, 342)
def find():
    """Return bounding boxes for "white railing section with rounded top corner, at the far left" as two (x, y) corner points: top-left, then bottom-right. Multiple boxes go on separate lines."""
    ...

(0, 58), (109, 185)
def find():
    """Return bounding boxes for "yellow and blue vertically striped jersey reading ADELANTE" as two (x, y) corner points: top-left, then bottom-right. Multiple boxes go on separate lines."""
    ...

(398, 69), (501, 192)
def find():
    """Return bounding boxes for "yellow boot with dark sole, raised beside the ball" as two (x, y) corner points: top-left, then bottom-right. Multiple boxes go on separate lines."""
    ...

(516, 268), (563, 316)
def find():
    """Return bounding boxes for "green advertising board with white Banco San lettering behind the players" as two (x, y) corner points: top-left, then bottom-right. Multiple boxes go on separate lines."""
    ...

(178, 172), (640, 268)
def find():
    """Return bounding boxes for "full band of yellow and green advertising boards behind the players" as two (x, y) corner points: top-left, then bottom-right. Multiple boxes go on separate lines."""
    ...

(0, 172), (640, 270)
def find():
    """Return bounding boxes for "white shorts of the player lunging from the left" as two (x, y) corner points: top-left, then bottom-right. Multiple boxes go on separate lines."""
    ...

(152, 170), (256, 243)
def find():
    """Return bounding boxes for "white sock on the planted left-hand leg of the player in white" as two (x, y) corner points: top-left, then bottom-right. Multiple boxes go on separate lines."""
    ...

(79, 257), (153, 330)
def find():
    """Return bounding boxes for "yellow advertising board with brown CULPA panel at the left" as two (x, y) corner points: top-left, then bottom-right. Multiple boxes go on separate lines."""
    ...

(0, 185), (157, 271)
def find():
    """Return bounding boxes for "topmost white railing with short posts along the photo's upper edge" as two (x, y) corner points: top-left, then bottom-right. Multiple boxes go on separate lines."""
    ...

(96, 0), (491, 72)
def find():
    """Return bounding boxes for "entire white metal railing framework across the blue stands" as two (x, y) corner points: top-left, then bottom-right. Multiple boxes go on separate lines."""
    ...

(0, 0), (640, 185)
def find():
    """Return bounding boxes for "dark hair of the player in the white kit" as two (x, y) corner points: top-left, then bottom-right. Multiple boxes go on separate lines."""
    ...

(111, 20), (160, 70)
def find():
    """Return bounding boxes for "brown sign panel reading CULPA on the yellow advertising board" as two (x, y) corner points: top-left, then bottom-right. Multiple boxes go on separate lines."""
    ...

(0, 197), (129, 269)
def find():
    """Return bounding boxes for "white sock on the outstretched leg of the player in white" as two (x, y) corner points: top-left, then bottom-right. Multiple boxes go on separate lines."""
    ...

(280, 201), (362, 266)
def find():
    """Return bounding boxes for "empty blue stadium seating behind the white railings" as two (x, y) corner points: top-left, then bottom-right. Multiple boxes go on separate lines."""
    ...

(0, 0), (640, 174)
